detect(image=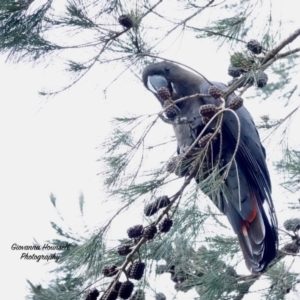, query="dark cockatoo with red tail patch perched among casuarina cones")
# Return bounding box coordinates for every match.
[143,61,278,274]
